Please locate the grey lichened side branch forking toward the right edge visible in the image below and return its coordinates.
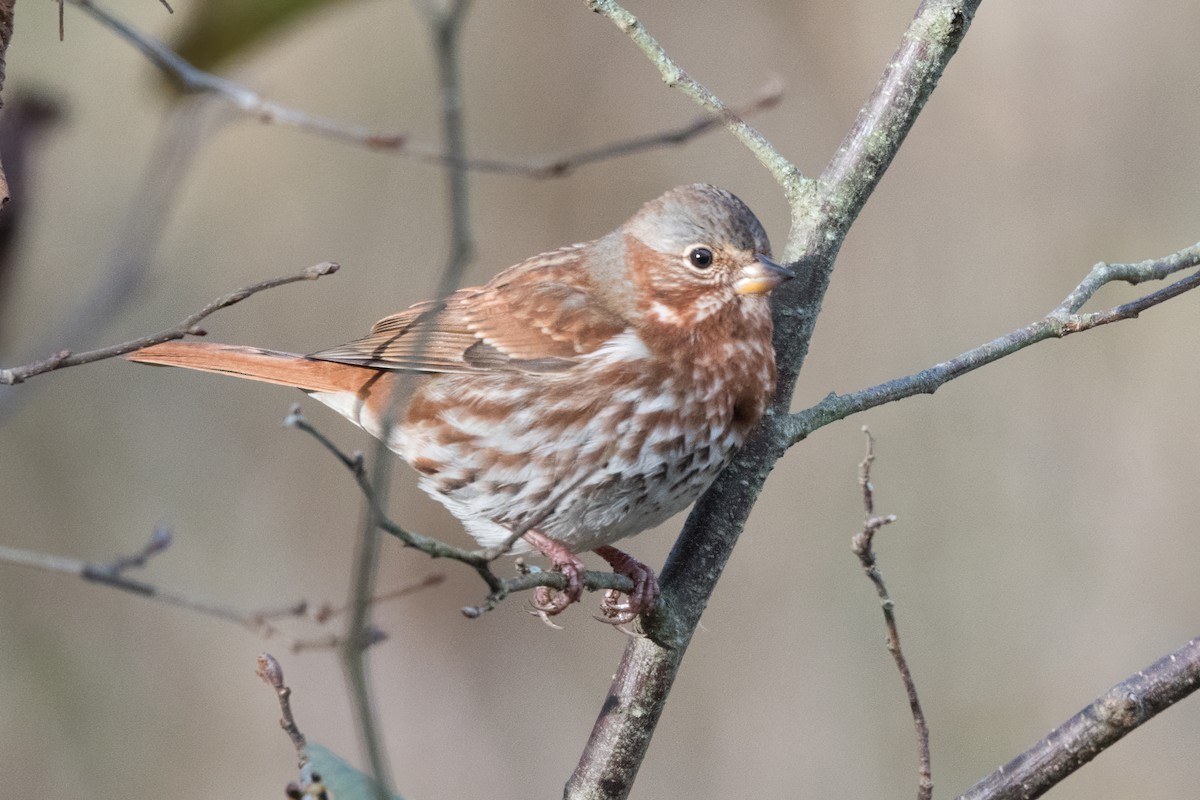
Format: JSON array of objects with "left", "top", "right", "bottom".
[{"left": 780, "top": 242, "right": 1200, "bottom": 444}]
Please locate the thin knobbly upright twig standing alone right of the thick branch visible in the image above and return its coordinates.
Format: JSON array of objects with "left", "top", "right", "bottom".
[{"left": 851, "top": 425, "right": 934, "bottom": 800}]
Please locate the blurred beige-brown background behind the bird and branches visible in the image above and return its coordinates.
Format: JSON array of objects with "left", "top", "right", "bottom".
[{"left": 0, "top": 0, "right": 1200, "bottom": 800}]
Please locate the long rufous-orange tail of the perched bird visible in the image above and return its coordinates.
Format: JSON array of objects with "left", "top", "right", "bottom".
[{"left": 125, "top": 342, "right": 380, "bottom": 393}]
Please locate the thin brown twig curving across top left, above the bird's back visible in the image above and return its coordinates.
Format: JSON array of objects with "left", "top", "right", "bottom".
[{"left": 59, "top": 0, "right": 782, "bottom": 179}]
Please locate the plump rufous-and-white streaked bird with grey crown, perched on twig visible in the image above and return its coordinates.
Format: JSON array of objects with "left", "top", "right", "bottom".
[{"left": 126, "top": 184, "right": 794, "bottom": 622}]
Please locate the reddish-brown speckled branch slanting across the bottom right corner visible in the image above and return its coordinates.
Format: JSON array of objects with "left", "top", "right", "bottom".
[{"left": 959, "top": 638, "right": 1200, "bottom": 800}]
